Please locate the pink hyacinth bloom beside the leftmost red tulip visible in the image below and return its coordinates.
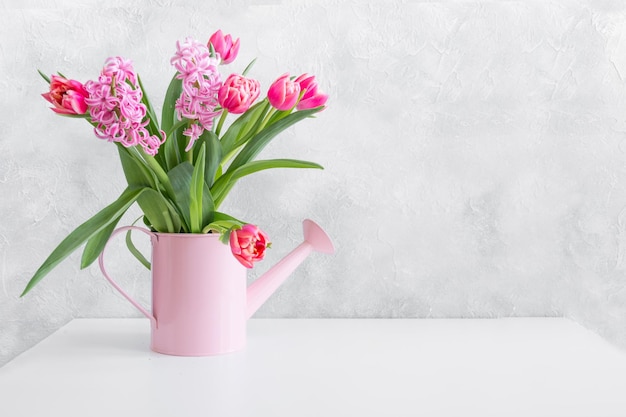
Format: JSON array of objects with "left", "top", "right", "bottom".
[{"left": 85, "top": 57, "right": 165, "bottom": 156}]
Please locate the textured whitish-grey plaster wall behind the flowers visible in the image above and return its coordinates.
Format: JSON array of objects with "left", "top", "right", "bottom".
[{"left": 0, "top": 0, "right": 626, "bottom": 364}]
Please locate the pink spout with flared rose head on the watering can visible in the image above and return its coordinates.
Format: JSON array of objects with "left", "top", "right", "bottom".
[{"left": 246, "top": 219, "right": 335, "bottom": 318}]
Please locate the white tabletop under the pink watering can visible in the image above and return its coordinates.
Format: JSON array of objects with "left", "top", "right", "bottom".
[{"left": 0, "top": 318, "right": 626, "bottom": 417}]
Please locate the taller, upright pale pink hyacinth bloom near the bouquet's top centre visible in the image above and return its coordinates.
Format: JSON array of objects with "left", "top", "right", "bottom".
[{"left": 170, "top": 38, "right": 222, "bottom": 150}]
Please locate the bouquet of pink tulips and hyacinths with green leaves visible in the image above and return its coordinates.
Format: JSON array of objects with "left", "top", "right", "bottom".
[{"left": 22, "top": 30, "right": 328, "bottom": 296}]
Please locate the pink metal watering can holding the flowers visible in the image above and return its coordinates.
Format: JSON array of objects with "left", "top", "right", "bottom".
[{"left": 98, "top": 219, "right": 334, "bottom": 356}]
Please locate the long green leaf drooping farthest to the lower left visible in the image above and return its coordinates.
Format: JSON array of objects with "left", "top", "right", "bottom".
[{"left": 21, "top": 187, "right": 148, "bottom": 297}]
